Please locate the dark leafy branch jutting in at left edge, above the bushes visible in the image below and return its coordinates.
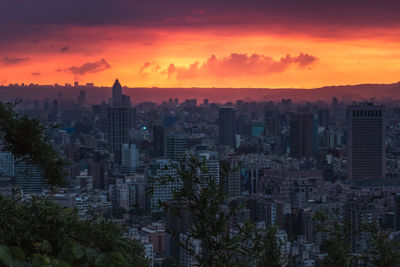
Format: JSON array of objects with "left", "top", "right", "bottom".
[{"left": 0, "top": 102, "right": 67, "bottom": 186}]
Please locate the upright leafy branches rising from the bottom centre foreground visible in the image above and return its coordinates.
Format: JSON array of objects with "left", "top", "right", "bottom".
[{"left": 153, "top": 156, "right": 283, "bottom": 266}]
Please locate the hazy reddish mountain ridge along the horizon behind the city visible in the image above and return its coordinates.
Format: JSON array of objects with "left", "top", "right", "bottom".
[{"left": 0, "top": 81, "right": 400, "bottom": 104}]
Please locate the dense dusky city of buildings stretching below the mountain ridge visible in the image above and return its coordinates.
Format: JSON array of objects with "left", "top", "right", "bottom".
[{"left": 0, "top": 80, "right": 400, "bottom": 267}]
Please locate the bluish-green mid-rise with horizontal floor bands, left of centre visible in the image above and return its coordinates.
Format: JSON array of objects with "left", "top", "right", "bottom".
[{"left": 165, "top": 133, "right": 188, "bottom": 160}]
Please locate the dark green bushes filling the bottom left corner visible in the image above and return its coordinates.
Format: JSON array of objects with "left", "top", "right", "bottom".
[{"left": 0, "top": 197, "right": 147, "bottom": 266}]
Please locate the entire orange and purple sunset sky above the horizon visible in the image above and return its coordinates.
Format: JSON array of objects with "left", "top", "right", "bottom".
[{"left": 0, "top": 0, "right": 400, "bottom": 88}]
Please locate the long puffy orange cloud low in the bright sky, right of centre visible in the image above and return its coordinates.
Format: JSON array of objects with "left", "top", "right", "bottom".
[{"left": 155, "top": 53, "right": 317, "bottom": 79}]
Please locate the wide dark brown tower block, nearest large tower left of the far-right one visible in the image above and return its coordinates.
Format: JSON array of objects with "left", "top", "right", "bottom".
[{"left": 289, "top": 113, "right": 318, "bottom": 158}]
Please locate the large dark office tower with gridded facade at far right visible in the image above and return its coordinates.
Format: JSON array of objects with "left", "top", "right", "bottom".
[{"left": 347, "top": 103, "right": 386, "bottom": 179}]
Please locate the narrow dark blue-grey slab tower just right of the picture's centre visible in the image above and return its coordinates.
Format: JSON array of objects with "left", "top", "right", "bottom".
[{"left": 219, "top": 107, "right": 236, "bottom": 148}]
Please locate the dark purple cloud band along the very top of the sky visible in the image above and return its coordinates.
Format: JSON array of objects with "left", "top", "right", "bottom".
[{"left": 0, "top": 0, "right": 400, "bottom": 29}]
